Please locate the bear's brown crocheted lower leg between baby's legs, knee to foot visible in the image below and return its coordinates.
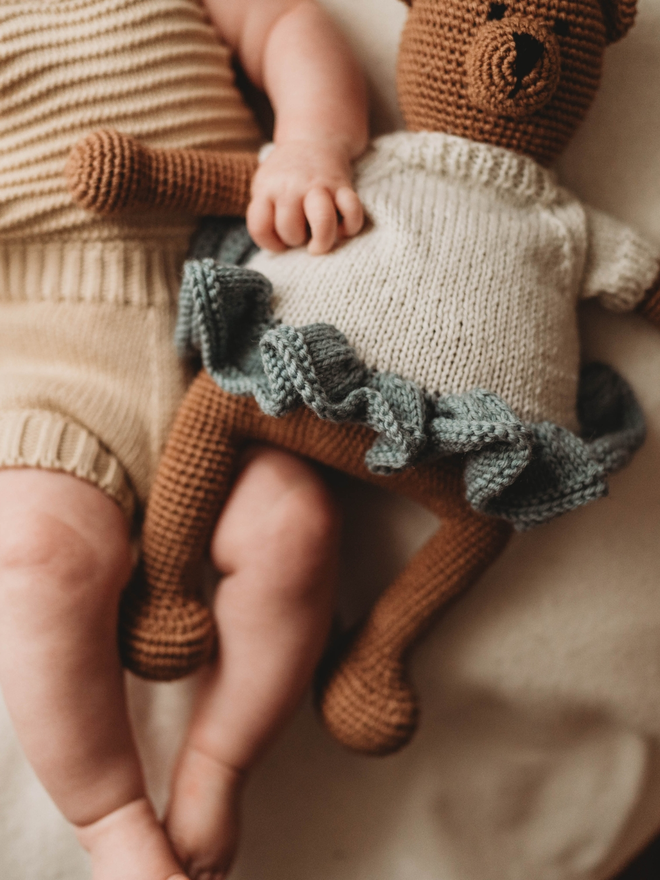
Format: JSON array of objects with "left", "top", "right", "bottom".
[{"left": 119, "top": 371, "right": 245, "bottom": 681}]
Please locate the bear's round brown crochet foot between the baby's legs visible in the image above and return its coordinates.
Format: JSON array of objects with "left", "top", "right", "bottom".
[{"left": 119, "top": 576, "right": 216, "bottom": 681}]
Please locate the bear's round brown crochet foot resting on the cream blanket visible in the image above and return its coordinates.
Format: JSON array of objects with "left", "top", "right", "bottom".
[{"left": 318, "top": 641, "right": 419, "bottom": 755}]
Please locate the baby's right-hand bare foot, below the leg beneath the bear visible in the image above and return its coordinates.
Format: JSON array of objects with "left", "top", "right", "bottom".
[{"left": 165, "top": 747, "right": 244, "bottom": 880}]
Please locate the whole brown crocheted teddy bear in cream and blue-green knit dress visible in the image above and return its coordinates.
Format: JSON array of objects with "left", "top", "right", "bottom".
[{"left": 68, "top": 0, "right": 660, "bottom": 754}]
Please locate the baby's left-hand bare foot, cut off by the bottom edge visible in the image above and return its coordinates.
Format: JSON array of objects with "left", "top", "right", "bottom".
[{"left": 75, "top": 798, "right": 187, "bottom": 880}]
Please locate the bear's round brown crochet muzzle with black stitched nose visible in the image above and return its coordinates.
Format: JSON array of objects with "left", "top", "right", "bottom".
[{"left": 466, "top": 16, "right": 561, "bottom": 116}]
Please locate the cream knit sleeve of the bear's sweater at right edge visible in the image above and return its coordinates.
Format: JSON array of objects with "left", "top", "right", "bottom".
[{"left": 580, "top": 207, "right": 660, "bottom": 312}]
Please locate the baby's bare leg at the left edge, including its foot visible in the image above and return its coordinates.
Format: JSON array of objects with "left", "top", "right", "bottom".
[{"left": 0, "top": 470, "right": 183, "bottom": 880}]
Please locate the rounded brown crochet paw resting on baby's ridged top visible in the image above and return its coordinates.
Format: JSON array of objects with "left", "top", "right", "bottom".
[{"left": 65, "top": 131, "right": 150, "bottom": 215}]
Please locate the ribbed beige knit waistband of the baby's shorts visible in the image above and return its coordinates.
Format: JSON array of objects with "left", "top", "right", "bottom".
[{"left": 0, "top": 240, "right": 187, "bottom": 307}]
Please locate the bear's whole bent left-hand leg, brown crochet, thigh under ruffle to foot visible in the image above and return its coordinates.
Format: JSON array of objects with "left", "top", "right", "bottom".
[{"left": 127, "top": 370, "right": 373, "bottom": 680}]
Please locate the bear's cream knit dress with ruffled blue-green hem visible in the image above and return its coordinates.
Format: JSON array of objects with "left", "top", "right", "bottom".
[{"left": 179, "top": 132, "right": 660, "bottom": 528}]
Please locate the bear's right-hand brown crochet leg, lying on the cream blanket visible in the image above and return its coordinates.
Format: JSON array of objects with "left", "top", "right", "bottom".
[{"left": 319, "top": 463, "right": 511, "bottom": 755}]
